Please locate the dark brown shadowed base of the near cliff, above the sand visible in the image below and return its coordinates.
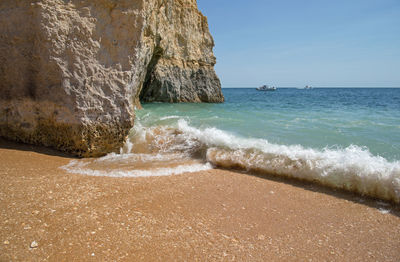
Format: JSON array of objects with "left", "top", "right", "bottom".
[{"left": 0, "top": 109, "right": 132, "bottom": 157}]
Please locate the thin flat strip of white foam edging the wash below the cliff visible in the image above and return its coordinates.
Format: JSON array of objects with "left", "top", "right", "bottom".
[{"left": 61, "top": 160, "right": 212, "bottom": 177}]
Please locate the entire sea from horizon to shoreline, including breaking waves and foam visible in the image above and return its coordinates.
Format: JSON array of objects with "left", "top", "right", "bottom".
[{"left": 63, "top": 88, "right": 400, "bottom": 203}]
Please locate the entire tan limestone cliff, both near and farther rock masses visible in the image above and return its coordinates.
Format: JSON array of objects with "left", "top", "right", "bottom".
[{"left": 0, "top": 0, "right": 224, "bottom": 156}]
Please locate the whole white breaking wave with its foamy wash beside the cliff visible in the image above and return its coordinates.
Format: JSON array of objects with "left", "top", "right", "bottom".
[{"left": 64, "top": 114, "right": 400, "bottom": 203}]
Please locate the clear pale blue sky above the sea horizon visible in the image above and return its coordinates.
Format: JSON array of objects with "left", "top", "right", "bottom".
[{"left": 197, "top": 0, "right": 400, "bottom": 87}]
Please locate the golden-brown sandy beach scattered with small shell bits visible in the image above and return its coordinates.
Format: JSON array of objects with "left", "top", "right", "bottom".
[{"left": 0, "top": 140, "right": 400, "bottom": 261}]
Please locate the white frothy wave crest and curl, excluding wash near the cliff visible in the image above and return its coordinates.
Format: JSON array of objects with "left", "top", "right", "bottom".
[{"left": 141, "top": 119, "right": 400, "bottom": 202}]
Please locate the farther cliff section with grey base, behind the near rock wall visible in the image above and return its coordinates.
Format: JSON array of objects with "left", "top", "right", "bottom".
[{"left": 140, "top": 0, "right": 224, "bottom": 102}]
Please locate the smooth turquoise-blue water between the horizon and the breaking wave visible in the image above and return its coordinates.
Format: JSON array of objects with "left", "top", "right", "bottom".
[{"left": 137, "top": 88, "right": 400, "bottom": 161}]
